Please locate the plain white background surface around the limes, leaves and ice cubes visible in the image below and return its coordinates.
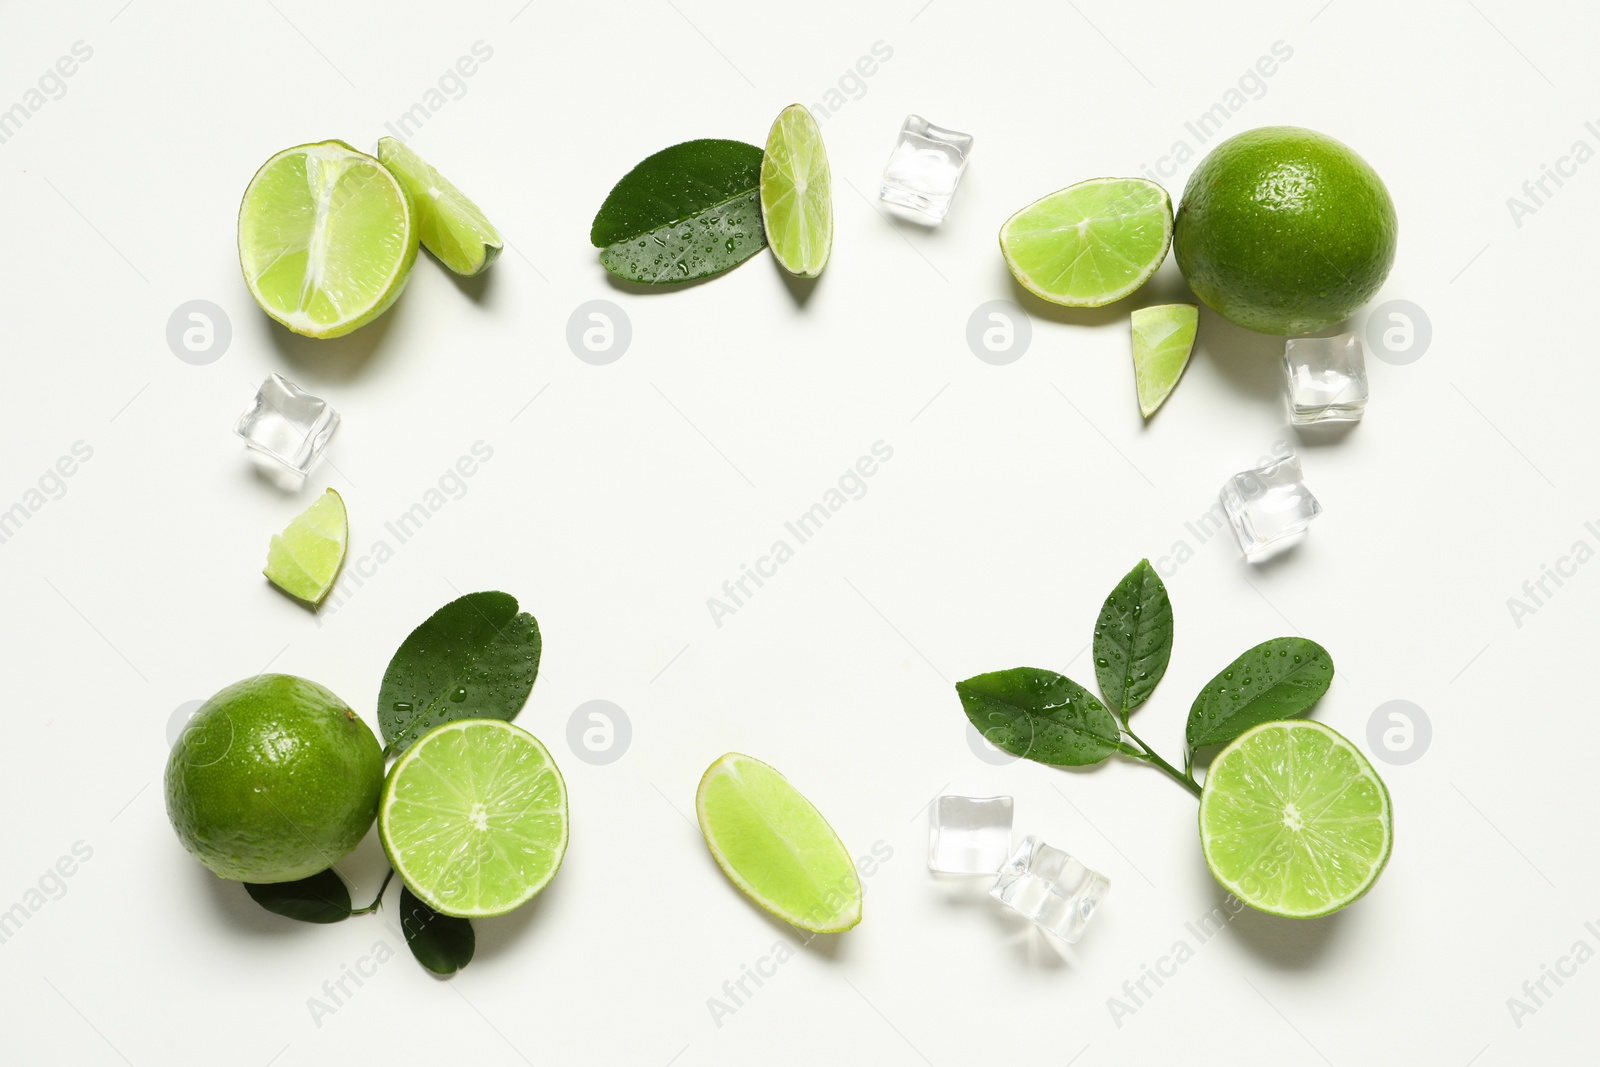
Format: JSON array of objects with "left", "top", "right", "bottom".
[{"left": 0, "top": 0, "right": 1600, "bottom": 1067}]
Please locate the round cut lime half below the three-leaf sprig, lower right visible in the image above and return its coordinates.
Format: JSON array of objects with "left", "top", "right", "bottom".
[{"left": 1200, "top": 720, "right": 1394, "bottom": 918}]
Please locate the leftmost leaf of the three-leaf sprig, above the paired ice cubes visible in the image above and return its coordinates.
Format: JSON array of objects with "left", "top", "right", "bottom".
[{"left": 955, "top": 667, "right": 1122, "bottom": 766}]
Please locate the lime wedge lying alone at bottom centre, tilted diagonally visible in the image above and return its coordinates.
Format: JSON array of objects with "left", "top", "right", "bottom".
[{"left": 694, "top": 752, "right": 861, "bottom": 934}]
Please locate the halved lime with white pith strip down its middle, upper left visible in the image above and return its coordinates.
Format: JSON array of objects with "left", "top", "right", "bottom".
[{"left": 238, "top": 141, "right": 418, "bottom": 338}]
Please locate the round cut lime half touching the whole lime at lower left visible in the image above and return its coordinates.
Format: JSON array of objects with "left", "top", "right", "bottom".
[{"left": 378, "top": 718, "right": 566, "bottom": 918}]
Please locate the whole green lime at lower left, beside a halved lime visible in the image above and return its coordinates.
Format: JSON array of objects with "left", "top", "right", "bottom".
[{"left": 166, "top": 675, "right": 384, "bottom": 881}]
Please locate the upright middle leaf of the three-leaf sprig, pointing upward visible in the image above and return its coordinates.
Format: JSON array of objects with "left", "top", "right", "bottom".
[{"left": 1094, "top": 560, "right": 1173, "bottom": 715}]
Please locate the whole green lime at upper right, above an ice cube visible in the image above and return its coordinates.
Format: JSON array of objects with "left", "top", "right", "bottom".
[{"left": 1173, "top": 126, "right": 1397, "bottom": 334}]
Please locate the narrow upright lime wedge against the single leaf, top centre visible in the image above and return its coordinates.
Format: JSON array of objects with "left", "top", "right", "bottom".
[{"left": 762, "top": 104, "right": 834, "bottom": 278}]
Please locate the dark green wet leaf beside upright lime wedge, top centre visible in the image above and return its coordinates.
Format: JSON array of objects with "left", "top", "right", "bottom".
[{"left": 589, "top": 139, "right": 766, "bottom": 285}]
